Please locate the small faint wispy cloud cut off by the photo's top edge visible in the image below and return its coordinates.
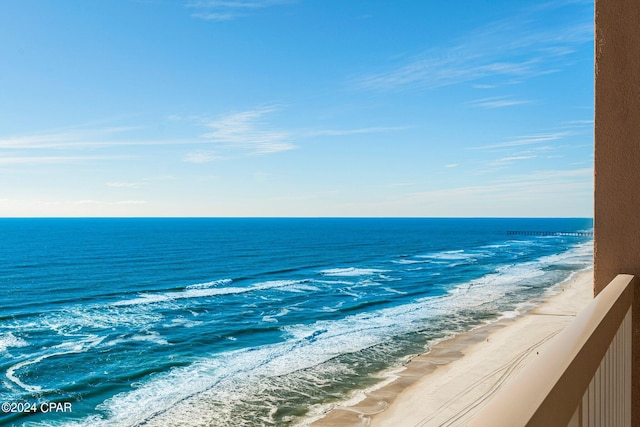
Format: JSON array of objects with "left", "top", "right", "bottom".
[{"left": 186, "top": 0, "right": 294, "bottom": 21}]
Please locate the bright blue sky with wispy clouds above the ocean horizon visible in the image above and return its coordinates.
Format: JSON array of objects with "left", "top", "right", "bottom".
[{"left": 0, "top": 0, "right": 593, "bottom": 217}]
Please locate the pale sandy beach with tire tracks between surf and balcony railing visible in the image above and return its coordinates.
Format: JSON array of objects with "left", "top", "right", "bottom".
[{"left": 311, "top": 270, "right": 593, "bottom": 427}]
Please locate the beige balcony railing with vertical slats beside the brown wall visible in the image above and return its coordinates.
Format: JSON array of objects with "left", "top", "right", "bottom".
[{"left": 467, "top": 274, "right": 637, "bottom": 427}]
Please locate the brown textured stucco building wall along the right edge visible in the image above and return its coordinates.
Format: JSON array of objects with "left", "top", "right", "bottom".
[{"left": 594, "top": 0, "right": 640, "bottom": 425}]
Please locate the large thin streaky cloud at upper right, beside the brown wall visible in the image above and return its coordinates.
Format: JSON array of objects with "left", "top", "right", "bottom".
[{"left": 354, "top": 4, "right": 593, "bottom": 90}]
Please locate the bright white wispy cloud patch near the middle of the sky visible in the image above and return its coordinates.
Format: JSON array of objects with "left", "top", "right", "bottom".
[{"left": 201, "top": 107, "right": 297, "bottom": 154}]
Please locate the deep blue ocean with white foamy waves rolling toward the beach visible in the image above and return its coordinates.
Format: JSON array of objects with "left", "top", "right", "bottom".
[{"left": 0, "top": 218, "right": 593, "bottom": 427}]
